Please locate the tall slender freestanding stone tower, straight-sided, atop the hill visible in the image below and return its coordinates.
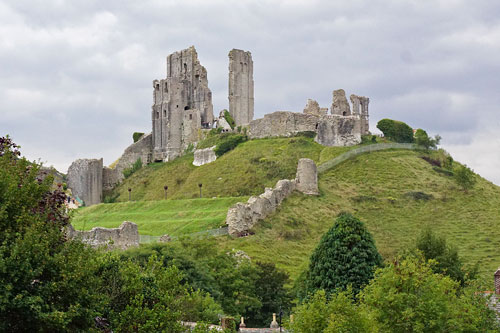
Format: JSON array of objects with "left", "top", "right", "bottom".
[{"left": 229, "top": 49, "right": 254, "bottom": 126}]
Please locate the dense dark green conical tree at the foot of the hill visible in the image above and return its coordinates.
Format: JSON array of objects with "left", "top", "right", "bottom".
[{"left": 307, "top": 213, "right": 382, "bottom": 294}]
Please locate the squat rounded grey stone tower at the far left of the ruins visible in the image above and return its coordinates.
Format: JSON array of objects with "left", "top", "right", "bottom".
[{"left": 68, "top": 158, "right": 103, "bottom": 206}]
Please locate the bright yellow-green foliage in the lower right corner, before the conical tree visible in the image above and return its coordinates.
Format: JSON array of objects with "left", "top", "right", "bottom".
[{"left": 290, "top": 257, "right": 499, "bottom": 333}]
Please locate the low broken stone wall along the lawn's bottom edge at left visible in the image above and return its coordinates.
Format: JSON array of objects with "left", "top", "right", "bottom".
[{"left": 66, "top": 221, "right": 139, "bottom": 250}]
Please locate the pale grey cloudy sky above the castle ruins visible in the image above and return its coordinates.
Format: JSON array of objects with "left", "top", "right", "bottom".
[{"left": 0, "top": 0, "right": 500, "bottom": 185}]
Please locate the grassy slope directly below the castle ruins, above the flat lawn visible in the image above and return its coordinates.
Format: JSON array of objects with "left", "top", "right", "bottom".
[{"left": 112, "top": 137, "right": 351, "bottom": 201}]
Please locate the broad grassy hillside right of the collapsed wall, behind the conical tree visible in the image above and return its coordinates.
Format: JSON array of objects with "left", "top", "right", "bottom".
[{"left": 221, "top": 150, "right": 500, "bottom": 285}]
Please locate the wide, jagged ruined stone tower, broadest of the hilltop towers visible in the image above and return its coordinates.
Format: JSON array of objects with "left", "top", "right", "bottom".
[{"left": 151, "top": 46, "right": 214, "bottom": 161}]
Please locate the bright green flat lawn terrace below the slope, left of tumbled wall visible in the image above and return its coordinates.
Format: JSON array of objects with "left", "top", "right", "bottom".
[{"left": 71, "top": 197, "right": 248, "bottom": 236}]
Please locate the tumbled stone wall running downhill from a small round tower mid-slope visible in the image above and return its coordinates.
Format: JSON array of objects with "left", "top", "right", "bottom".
[{"left": 226, "top": 158, "right": 319, "bottom": 236}]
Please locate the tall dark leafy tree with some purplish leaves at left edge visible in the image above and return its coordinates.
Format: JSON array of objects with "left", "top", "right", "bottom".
[{"left": 0, "top": 137, "right": 100, "bottom": 332}]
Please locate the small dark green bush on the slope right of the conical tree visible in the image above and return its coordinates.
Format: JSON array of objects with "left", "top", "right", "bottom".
[{"left": 416, "top": 228, "right": 477, "bottom": 286}]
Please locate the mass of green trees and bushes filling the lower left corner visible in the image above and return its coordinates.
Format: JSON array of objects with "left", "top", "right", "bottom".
[{"left": 0, "top": 138, "right": 222, "bottom": 332}]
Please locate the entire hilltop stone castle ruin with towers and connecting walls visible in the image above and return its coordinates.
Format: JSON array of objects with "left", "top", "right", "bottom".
[{"left": 68, "top": 46, "right": 370, "bottom": 206}]
